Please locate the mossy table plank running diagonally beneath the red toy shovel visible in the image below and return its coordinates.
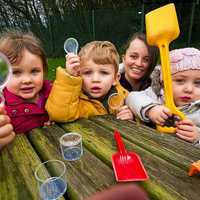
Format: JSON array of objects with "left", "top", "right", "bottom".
[{"left": 63, "top": 119, "right": 200, "bottom": 199}]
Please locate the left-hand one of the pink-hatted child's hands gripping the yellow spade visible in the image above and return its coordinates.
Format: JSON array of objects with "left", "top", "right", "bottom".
[{"left": 146, "top": 105, "right": 172, "bottom": 126}]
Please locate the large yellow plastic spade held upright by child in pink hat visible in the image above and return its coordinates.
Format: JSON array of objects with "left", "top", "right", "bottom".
[{"left": 145, "top": 3, "right": 185, "bottom": 133}]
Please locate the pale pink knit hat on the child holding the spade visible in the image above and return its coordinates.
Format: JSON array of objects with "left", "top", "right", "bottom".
[{"left": 169, "top": 48, "right": 200, "bottom": 74}]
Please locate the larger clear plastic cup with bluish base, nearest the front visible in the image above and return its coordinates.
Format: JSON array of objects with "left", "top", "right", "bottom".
[{"left": 35, "top": 160, "right": 67, "bottom": 200}]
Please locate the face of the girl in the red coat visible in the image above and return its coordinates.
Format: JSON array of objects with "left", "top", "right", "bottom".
[{"left": 7, "top": 49, "right": 44, "bottom": 102}]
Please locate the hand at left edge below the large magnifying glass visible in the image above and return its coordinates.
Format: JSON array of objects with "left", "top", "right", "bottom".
[{"left": 0, "top": 107, "right": 15, "bottom": 149}]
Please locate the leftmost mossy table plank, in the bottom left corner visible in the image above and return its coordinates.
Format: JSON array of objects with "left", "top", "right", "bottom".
[{"left": 0, "top": 135, "right": 43, "bottom": 200}]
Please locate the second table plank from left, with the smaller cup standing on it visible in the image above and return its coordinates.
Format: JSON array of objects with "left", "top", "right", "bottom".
[{"left": 29, "top": 125, "right": 115, "bottom": 200}]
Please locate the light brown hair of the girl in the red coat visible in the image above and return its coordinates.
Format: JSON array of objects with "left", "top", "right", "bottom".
[{"left": 0, "top": 30, "right": 48, "bottom": 72}]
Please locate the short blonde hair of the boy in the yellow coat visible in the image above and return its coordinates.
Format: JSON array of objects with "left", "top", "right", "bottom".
[{"left": 79, "top": 41, "right": 119, "bottom": 74}]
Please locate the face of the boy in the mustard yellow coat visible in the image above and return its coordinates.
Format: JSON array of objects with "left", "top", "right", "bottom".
[{"left": 80, "top": 60, "right": 117, "bottom": 99}]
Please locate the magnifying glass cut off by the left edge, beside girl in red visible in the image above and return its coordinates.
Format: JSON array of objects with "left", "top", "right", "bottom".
[{"left": 0, "top": 52, "right": 12, "bottom": 106}]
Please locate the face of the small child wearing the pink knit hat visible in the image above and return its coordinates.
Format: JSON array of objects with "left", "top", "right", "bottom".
[{"left": 172, "top": 70, "right": 200, "bottom": 106}]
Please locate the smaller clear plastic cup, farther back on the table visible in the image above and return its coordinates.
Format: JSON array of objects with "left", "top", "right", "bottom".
[{"left": 60, "top": 132, "right": 83, "bottom": 161}]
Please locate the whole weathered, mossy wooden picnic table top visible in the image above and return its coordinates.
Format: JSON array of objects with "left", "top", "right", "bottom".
[{"left": 0, "top": 115, "right": 200, "bottom": 200}]
